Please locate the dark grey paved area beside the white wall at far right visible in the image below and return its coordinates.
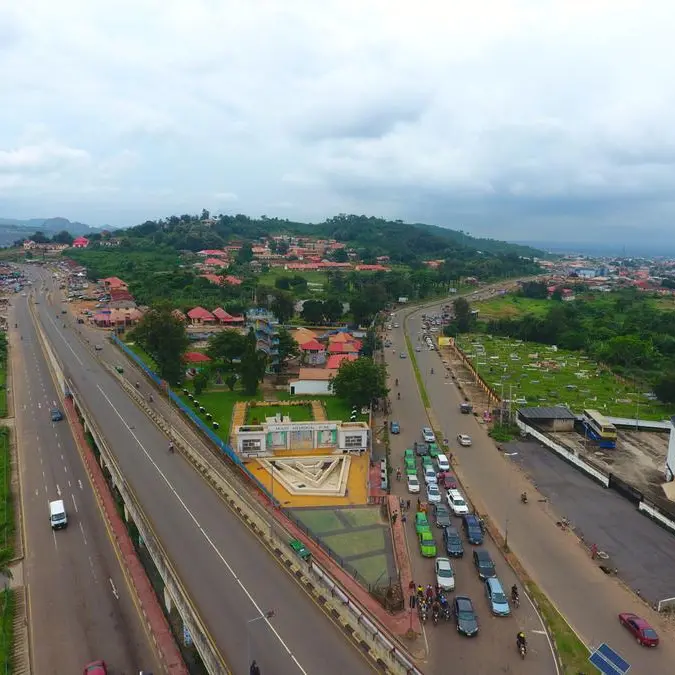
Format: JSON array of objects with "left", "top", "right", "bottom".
[{"left": 504, "top": 441, "right": 675, "bottom": 604}]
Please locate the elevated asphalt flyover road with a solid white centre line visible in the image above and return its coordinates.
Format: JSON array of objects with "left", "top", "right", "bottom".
[{"left": 26, "top": 270, "right": 371, "bottom": 675}]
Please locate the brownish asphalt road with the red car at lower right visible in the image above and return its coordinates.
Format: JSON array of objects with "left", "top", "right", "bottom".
[{"left": 390, "top": 306, "right": 675, "bottom": 673}]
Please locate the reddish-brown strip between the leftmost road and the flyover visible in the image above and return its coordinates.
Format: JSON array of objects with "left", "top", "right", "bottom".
[{"left": 31, "top": 310, "right": 191, "bottom": 675}]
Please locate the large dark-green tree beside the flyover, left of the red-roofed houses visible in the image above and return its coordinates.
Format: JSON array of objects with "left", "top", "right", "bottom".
[{"left": 131, "top": 305, "right": 190, "bottom": 384}]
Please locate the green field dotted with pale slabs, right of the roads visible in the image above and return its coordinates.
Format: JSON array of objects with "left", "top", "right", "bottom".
[{"left": 457, "top": 334, "right": 673, "bottom": 420}]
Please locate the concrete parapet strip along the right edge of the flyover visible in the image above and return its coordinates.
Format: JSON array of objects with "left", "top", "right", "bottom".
[{"left": 106, "top": 366, "right": 428, "bottom": 675}]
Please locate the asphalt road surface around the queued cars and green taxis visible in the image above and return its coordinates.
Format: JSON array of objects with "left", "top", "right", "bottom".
[{"left": 386, "top": 327, "right": 556, "bottom": 675}]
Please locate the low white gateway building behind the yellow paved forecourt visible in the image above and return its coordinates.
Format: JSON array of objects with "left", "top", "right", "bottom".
[{"left": 234, "top": 417, "right": 369, "bottom": 459}]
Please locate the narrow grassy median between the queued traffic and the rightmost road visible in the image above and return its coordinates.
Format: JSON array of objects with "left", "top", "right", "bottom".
[{"left": 402, "top": 312, "right": 568, "bottom": 672}]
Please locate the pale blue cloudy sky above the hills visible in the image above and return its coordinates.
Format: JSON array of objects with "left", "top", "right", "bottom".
[{"left": 0, "top": 0, "right": 675, "bottom": 248}]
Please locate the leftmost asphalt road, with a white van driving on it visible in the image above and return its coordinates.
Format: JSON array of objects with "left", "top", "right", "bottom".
[{"left": 9, "top": 296, "right": 159, "bottom": 675}]
